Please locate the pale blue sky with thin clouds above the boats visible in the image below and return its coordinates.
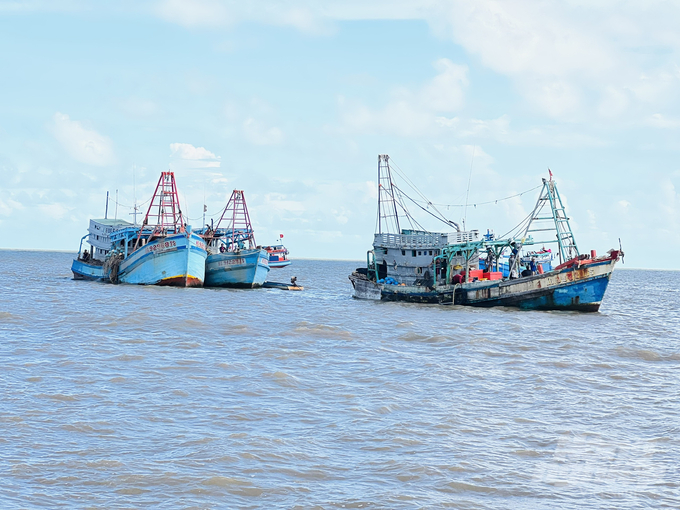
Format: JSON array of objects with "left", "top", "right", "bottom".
[{"left": 0, "top": 0, "right": 680, "bottom": 269}]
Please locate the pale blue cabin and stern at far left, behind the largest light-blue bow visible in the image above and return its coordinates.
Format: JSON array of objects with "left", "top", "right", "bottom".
[{"left": 71, "top": 217, "right": 132, "bottom": 280}]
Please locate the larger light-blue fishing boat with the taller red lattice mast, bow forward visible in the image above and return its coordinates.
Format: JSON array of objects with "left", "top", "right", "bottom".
[{"left": 103, "top": 172, "right": 207, "bottom": 287}]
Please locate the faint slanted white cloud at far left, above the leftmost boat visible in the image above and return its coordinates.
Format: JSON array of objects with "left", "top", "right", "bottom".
[{"left": 49, "top": 112, "right": 116, "bottom": 166}]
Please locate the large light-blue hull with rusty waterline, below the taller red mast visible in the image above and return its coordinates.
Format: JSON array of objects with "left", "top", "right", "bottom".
[{"left": 117, "top": 233, "right": 207, "bottom": 287}]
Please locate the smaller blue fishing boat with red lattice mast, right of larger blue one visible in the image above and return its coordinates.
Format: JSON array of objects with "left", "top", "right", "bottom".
[{"left": 201, "top": 190, "right": 269, "bottom": 288}]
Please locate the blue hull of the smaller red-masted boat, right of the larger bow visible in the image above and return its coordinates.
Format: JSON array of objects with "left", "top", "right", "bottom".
[{"left": 204, "top": 249, "right": 269, "bottom": 288}]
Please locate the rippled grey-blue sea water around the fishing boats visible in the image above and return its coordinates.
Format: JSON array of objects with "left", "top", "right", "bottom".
[{"left": 0, "top": 251, "right": 680, "bottom": 509}]
